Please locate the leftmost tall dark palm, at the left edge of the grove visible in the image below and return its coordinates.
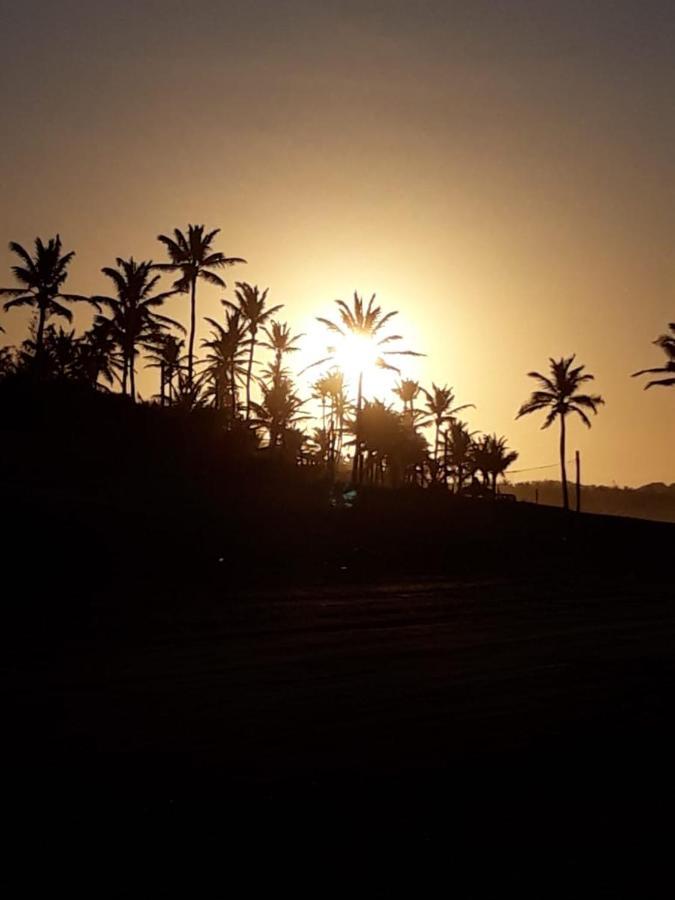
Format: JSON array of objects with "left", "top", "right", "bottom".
[{"left": 0, "top": 234, "right": 96, "bottom": 366}]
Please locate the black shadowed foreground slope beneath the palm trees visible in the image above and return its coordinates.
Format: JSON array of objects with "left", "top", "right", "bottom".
[{"left": 0, "top": 383, "right": 675, "bottom": 898}]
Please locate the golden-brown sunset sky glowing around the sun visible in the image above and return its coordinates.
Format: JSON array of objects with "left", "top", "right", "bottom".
[{"left": 0, "top": 0, "right": 675, "bottom": 485}]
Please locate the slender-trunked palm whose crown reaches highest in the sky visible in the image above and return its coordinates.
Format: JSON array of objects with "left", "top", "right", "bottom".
[{"left": 155, "top": 225, "right": 246, "bottom": 383}]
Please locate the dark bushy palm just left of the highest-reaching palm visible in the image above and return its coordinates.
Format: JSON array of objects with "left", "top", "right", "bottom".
[{"left": 93, "top": 257, "right": 185, "bottom": 402}]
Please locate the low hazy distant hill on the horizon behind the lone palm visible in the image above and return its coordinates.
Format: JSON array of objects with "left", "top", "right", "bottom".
[{"left": 503, "top": 481, "right": 675, "bottom": 522}]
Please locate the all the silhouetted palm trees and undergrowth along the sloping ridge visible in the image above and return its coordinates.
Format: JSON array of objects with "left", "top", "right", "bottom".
[{"left": 0, "top": 225, "right": 675, "bottom": 507}]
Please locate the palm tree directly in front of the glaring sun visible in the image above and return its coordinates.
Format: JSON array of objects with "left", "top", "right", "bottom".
[{"left": 313, "top": 292, "right": 423, "bottom": 483}]
